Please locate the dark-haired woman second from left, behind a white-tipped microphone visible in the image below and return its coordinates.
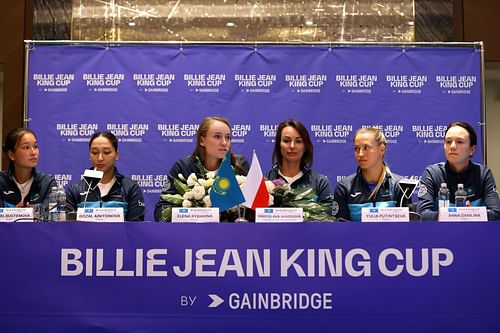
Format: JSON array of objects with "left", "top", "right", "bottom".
[{"left": 66, "top": 132, "right": 145, "bottom": 221}]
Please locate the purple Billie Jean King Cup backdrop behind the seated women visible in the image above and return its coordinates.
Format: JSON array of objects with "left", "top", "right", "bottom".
[{"left": 28, "top": 44, "right": 482, "bottom": 220}]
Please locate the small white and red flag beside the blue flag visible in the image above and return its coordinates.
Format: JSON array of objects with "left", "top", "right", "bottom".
[{"left": 241, "top": 151, "right": 269, "bottom": 209}]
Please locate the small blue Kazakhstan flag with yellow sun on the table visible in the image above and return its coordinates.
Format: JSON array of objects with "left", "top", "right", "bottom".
[{"left": 210, "top": 151, "right": 245, "bottom": 212}]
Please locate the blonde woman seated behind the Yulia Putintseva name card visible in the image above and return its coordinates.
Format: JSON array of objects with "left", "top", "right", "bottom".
[{"left": 332, "top": 127, "right": 403, "bottom": 221}]
